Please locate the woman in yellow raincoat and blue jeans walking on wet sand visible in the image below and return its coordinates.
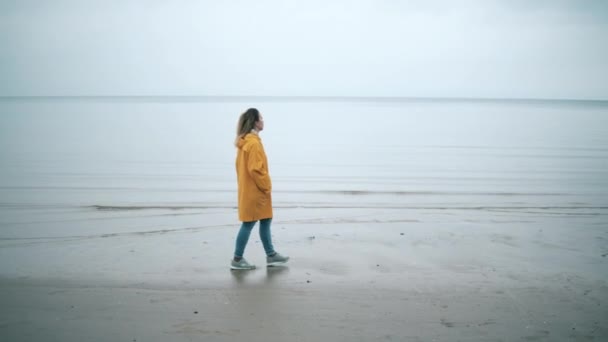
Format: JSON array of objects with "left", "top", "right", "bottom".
[{"left": 230, "top": 108, "right": 289, "bottom": 270}]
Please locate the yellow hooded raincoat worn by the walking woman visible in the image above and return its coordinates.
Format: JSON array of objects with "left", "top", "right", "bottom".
[{"left": 236, "top": 133, "right": 272, "bottom": 222}]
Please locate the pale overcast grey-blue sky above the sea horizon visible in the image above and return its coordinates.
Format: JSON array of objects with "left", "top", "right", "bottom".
[{"left": 0, "top": 0, "right": 608, "bottom": 99}]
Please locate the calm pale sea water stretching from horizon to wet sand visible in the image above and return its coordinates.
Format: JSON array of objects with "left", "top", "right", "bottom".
[{"left": 0, "top": 98, "right": 608, "bottom": 241}]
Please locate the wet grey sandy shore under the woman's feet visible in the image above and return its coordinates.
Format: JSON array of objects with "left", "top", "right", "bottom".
[{"left": 0, "top": 204, "right": 608, "bottom": 342}]
